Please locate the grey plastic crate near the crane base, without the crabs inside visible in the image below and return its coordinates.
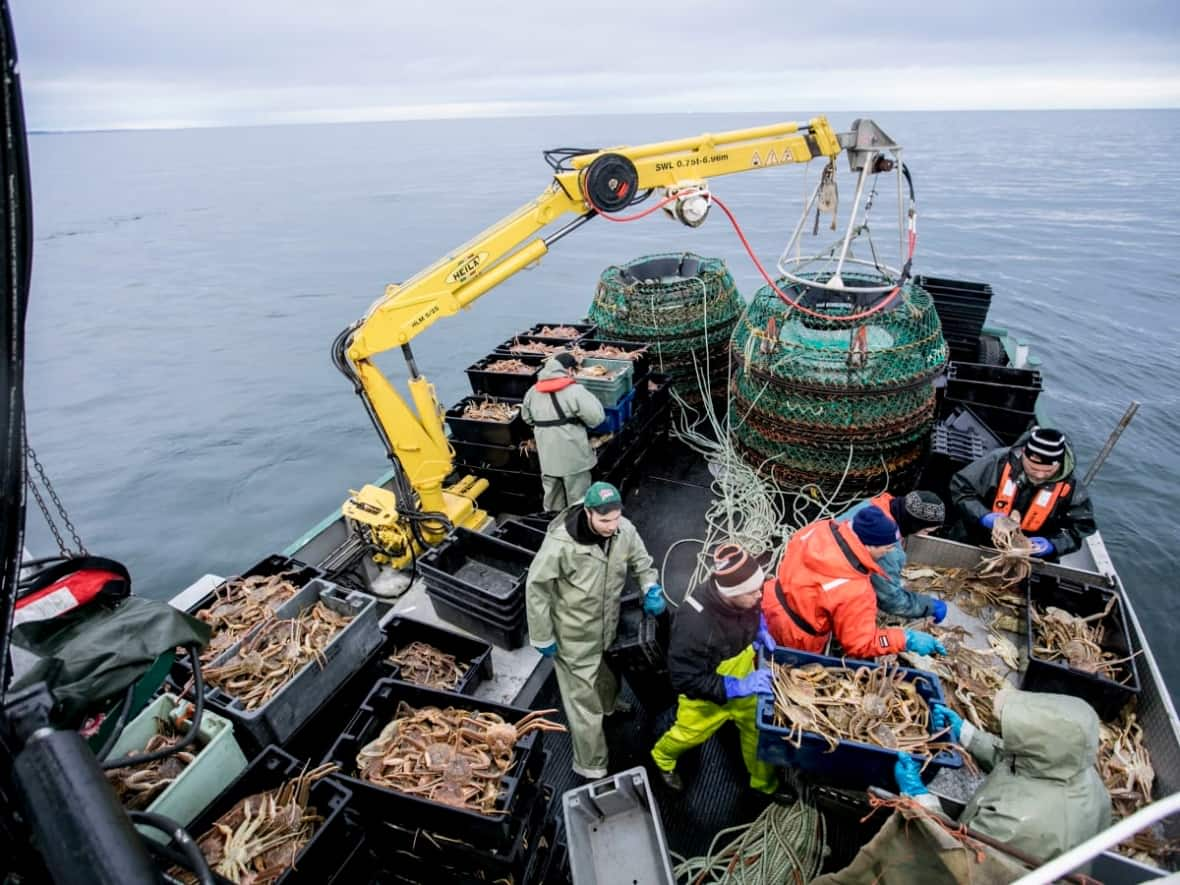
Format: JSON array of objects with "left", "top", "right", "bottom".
[{"left": 199, "top": 578, "right": 384, "bottom": 749}]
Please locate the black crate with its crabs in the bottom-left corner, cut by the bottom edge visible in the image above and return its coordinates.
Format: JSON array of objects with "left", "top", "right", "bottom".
[{"left": 162, "top": 747, "right": 354, "bottom": 885}]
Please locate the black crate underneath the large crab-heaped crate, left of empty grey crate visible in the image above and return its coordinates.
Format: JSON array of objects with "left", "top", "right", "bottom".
[{"left": 359, "top": 784, "right": 553, "bottom": 885}]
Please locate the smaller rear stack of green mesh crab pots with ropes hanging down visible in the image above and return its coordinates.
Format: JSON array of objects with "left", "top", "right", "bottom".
[{"left": 589, "top": 253, "right": 745, "bottom": 404}]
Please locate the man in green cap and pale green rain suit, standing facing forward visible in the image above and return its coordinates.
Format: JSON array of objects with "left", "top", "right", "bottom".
[{"left": 525, "top": 483, "right": 664, "bottom": 779}]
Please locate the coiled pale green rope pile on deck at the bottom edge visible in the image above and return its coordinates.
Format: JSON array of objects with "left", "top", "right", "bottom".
[{"left": 673, "top": 802, "right": 825, "bottom": 885}]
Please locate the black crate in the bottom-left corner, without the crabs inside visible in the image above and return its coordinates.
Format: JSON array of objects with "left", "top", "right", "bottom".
[{"left": 161, "top": 747, "right": 353, "bottom": 885}]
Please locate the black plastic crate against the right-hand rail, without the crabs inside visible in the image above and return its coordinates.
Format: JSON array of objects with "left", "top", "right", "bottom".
[{"left": 1021, "top": 572, "right": 1139, "bottom": 720}]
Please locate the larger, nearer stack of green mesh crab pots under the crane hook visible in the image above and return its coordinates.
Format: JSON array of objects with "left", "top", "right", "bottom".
[{"left": 729, "top": 274, "right": 946, "bottom": 497}]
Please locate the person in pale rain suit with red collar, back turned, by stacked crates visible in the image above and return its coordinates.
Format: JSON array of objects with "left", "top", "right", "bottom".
[{"left": 520, "top": 353, "right": 607, "bottom": 512}]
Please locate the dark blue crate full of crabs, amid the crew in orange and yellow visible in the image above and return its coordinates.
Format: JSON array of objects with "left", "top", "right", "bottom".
[{"left": 758, "top": 648, "right": 963, "bottom": 789}]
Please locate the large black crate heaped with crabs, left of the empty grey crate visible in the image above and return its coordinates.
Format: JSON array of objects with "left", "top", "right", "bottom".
[{"left": 325, "top": 680, "right": 565, "bottom": 847}]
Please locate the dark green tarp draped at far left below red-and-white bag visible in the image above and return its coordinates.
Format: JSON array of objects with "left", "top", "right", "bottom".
[{"left": 12, "top": 596, "right": 209, "bottom": 727}]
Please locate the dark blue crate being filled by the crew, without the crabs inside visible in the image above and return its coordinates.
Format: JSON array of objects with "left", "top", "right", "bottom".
[{"left": 758, "top": 648, "right": 963, "bottom": 789}]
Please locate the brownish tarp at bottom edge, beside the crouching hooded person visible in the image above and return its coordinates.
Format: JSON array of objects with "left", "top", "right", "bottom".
[{"left": 812, "top": 808, "right": 1028, "bottom": 885}]
